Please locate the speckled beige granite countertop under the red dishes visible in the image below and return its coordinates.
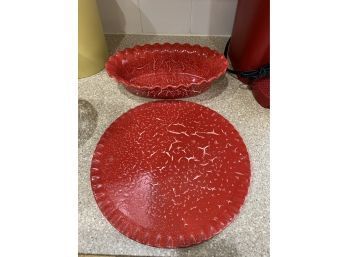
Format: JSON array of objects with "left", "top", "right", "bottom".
[{"left": 78, "top": 35, "right": 270, "bottom": 257}]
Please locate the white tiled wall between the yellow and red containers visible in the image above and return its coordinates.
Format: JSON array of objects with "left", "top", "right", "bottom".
[{"left": 97, "top": 0, "right": 237, "bottom": 36}]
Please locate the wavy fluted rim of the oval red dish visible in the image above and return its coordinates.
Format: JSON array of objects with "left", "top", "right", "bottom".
[{"left": 105, "top": 42, "right": 228, "bottom": 90}]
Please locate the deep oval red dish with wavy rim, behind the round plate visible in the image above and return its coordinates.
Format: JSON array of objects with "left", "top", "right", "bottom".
[{"left": 105, "top": 43, "right": 227, "bottom": 98}]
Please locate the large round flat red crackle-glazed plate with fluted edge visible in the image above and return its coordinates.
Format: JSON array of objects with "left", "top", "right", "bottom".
[{"left": 91, "top": 101, "right": 250, "bottom": 248}]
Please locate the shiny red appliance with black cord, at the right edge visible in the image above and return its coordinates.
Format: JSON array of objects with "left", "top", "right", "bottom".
[{"left": 225, "top": 0, "right": 270, "bottom": 108}]
